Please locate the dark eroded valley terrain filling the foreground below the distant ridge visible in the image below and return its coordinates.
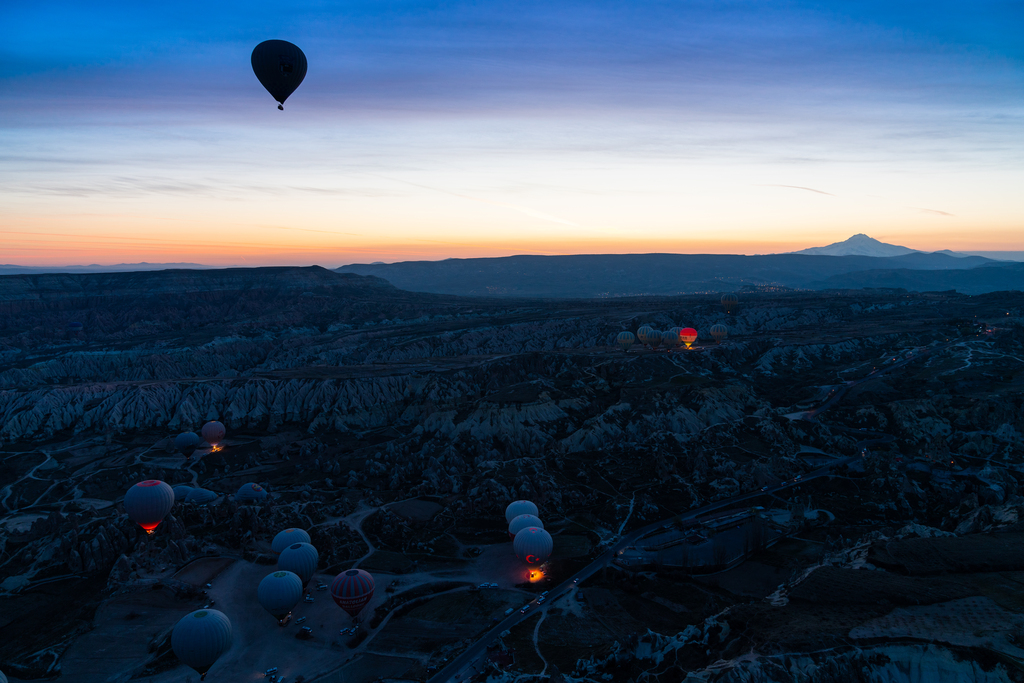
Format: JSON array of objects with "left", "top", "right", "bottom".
[{"left": 0, "top": 266, "right": 1024, "bottom": 683}]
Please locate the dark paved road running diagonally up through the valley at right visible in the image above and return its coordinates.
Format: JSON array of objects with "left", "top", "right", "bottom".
[{"left": 428, "top": 340, "right": 963, "bottom": 683}]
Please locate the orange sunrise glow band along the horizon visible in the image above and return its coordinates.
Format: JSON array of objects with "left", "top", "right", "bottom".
[{"left": 8, "top": 219, "right": 1024, "bottom": 267}]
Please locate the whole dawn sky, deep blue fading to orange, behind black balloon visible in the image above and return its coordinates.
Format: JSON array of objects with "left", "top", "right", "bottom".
[{"left": 0, "top": 0, "right": 1024, "bottom": 265}]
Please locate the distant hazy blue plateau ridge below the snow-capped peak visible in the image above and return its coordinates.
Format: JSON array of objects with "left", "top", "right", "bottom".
[{"left": 338, "top": 252, "right": 1024, "bottom": 298}]
